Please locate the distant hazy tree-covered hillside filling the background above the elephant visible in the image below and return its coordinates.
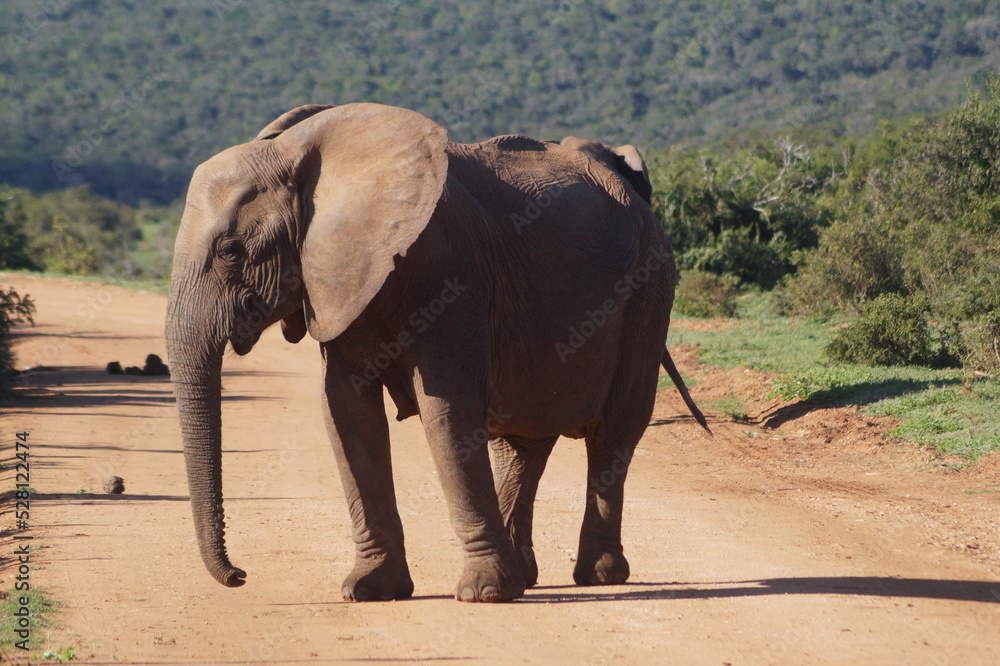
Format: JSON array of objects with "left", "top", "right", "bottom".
[{"left": 0, "top": 0, "right": 1000, "bottom": 204}]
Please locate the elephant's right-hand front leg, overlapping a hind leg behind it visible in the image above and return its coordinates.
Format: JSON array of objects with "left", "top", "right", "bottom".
[{"left": 420, "top": 396, "right": 525, "bottom": 602}]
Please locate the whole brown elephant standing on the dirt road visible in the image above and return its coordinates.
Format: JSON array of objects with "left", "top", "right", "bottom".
[{"left": 165, "top": 103, "right": 708, "bottom": 602}]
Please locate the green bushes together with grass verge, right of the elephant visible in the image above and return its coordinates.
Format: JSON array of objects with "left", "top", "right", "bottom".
[{"left": 655, "top": 79, "right": 1000, "bottom": 460}]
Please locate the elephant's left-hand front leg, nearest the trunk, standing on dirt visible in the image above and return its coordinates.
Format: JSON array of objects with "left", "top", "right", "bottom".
[{"left": 323, "top": 345, "right": 413, "bottom": 601}]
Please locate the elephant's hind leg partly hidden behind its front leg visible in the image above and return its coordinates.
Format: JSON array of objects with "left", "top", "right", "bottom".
[{"left": 490, "top": 436, "right": 558, "bottom": 587}]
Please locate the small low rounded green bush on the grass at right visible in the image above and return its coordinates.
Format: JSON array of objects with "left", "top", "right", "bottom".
[{"left": 826, "top": 294, "right": 956, "bottom": 367}]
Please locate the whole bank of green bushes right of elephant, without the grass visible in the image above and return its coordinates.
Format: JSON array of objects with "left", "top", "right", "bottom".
[{"left": 653, "top": 79, "right": 1000, "bottom": 375}]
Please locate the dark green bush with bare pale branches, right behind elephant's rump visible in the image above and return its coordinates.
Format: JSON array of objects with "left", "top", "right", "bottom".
[{"left": 650, "top": 138, "right": 842, "bottom": 289}]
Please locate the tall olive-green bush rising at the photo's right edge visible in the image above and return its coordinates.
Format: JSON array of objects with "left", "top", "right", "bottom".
[{"left": 787, "top": 79, "right": 1000, "bottom": 374}]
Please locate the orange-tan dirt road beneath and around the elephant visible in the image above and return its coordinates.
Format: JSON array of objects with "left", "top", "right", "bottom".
[{"left": 0, "top": 275, "right": 1000, "bottom": 664}]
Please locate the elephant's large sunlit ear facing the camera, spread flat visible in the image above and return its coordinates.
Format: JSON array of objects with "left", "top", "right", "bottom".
[{"left": 274, "top": 104, "right": 448, "bottom": 342}]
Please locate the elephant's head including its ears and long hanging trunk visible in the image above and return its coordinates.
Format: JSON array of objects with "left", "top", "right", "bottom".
[{"left": 166, "top": 104, "right": 448, "bottom": 586}]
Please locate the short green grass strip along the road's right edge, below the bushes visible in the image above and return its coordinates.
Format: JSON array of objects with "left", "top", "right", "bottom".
[{"left": 670, "top": 310, "right": 1000, "bottom": 462}]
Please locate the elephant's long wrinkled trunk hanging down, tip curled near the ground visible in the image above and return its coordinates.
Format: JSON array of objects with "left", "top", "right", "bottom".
[{"left": 166, "top": 281, "right": 246, "bottom": 587}]
